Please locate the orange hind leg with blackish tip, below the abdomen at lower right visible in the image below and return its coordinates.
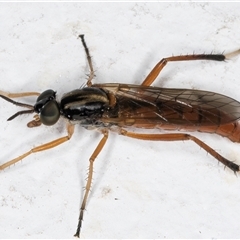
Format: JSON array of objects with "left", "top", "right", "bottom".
[{"left": 119, "top": 129, "right": 240, "bottom": 173}]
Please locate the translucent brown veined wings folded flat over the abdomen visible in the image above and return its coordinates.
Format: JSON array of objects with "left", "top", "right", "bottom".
[{"left": 93, "top": 84, "right": 240, "bottom": 126}]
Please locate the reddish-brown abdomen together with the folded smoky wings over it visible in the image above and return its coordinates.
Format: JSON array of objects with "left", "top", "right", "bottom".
[{"left": 92, "top": 83, "right": 240, "bottom": 142}]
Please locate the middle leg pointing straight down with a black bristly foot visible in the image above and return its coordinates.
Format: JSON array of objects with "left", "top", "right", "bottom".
[{"left": 74, "top": 130, "right": 108, "bottom": 237}]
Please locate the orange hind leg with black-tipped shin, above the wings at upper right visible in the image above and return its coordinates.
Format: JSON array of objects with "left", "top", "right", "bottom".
[{"left": 142, "top": 54, "right": 226, "bottom": 86}]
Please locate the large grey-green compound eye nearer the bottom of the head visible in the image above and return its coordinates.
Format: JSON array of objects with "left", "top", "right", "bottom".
[{"left": 40, "top": 101, "right": 60, "bottom": 126}]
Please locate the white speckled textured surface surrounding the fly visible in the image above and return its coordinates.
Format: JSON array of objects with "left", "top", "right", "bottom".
[{"left": 0, "top": 3, "right": 240, "bottom": 238}]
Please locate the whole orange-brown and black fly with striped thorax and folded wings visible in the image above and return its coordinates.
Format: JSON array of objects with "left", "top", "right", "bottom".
[{"left": 0, "top": 35, "right": 240, "bottom": 237}]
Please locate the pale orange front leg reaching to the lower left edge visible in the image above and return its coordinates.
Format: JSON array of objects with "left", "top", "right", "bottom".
[{"left": 0, "top": 124, "right": 74, "bottom": 171}]
